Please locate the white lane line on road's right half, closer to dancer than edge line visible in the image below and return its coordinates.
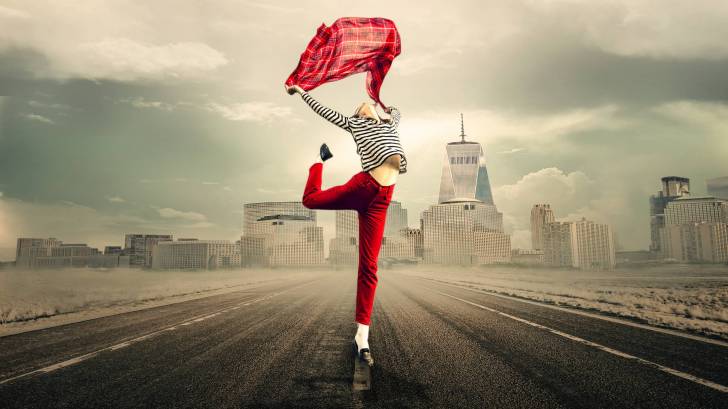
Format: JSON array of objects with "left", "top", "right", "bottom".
[{"left": 435, "top": 290, "right": 728, "bottom": 393}]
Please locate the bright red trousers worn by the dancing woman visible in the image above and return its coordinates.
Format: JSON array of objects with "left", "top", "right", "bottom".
[{"left": 303, "top": 162, "right": 394, "bottom": 325}]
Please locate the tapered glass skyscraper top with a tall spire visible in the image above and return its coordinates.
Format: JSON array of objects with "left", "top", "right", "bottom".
[{"left": 438, "top": 114, "right": 494, "bottom": 205}]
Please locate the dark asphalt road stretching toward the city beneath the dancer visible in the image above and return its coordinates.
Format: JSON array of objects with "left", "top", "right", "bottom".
[{"left": 0, "top": 270, "right": 728, "bottom": 408}]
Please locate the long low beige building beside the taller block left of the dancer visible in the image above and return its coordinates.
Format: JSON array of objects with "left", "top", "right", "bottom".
[{"left": 152, "top": 239, "right": 241, "bottom": 270}]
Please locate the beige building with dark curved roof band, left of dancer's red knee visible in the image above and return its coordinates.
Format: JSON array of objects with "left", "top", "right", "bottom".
[{"left": 240, "top": 201, "right": 324, "bottom": 267}]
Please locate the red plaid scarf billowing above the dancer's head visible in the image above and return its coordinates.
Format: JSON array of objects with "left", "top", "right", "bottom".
[{"left": 286, "top": 17, "right": 402, "bottom": 108}]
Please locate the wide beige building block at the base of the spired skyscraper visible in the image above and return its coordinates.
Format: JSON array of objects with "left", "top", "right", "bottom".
[{"left": 421, "top": 198, "right": 511, "bottom": 265}]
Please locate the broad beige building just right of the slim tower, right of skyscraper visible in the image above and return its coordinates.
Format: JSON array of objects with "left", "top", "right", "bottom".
[{"left": 544, "top": 219, "right": 616, "bottom": 270}]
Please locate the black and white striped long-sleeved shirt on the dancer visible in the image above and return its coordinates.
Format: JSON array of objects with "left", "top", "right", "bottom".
[{"left": 301, "top": 91, "right": 407, "bottom": 173}]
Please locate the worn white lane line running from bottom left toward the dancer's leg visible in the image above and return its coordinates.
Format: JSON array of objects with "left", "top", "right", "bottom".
[{"left": 0, "top": 281, "right": 314, "bottom": 385}]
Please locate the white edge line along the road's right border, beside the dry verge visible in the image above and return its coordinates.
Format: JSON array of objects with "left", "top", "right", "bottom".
[{"left": 418, "top": 277, "right": 728, "bottom": 347}]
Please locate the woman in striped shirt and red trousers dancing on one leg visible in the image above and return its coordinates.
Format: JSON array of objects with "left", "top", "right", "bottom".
[{"left": 285, "top": 85, "right": 407, "bottom": 366}]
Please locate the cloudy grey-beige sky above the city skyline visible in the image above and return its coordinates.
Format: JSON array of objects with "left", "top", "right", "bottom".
[{"left": 0, "top": 0, "right": 728, "bottom": 258}]
